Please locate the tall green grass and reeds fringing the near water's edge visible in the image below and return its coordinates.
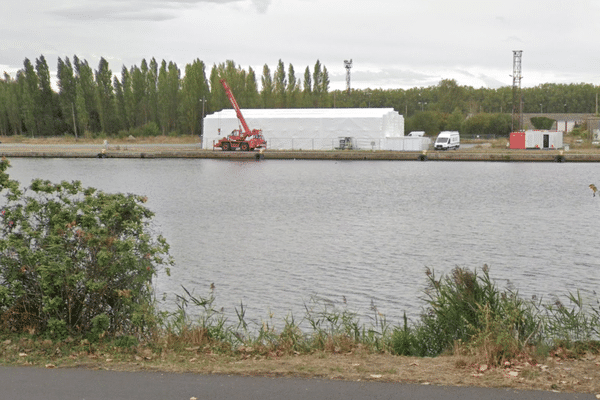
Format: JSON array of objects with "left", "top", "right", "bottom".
[{"left": 0, "top": 266, "right": 600, "bottom": 365}]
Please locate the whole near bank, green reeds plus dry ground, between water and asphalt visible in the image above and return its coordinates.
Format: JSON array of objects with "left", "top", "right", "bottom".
[{"left": 0, "top": 268, "right": 600, "bottom": 393}]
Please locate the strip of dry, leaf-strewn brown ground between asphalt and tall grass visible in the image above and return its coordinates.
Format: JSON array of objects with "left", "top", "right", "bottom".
[{"left": 0, "top": 340, "right": 600, "bottom": 398}]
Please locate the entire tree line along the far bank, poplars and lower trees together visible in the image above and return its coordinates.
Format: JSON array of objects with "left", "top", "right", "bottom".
[{"left": 0, "top": 55, "right": 599, "bottom": 137}]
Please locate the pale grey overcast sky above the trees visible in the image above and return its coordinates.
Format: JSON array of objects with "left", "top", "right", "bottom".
[{"left": 0, "top": 0, "right": 600, "bottom": 90}]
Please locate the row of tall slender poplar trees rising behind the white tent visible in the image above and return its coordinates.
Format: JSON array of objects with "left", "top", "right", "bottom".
[{"left": 0, "top": 56, "right": 331, "bottom": 137}]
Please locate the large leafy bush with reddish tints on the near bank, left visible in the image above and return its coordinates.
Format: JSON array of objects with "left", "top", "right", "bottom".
[{"left": 0, "top": 159, "right": 171, "bottom": 338}]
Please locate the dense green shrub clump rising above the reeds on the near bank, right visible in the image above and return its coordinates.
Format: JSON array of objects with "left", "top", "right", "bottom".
[{"left": 415, "top": 266, "right": 541, "bottom": 363}]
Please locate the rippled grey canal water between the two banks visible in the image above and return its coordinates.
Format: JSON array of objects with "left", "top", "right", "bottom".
[{"left": 4, "top": 159, "right": 600, "bottom": 326}]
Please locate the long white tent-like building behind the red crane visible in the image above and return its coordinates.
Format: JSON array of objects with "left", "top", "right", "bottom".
[{"left": 202, "top": 108, "right": 426, "bottom": 150}]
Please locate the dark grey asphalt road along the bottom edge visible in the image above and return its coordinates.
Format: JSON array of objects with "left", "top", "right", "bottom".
[{"left": 0, "top": 367, "right": 596, "bottom": 400}]
